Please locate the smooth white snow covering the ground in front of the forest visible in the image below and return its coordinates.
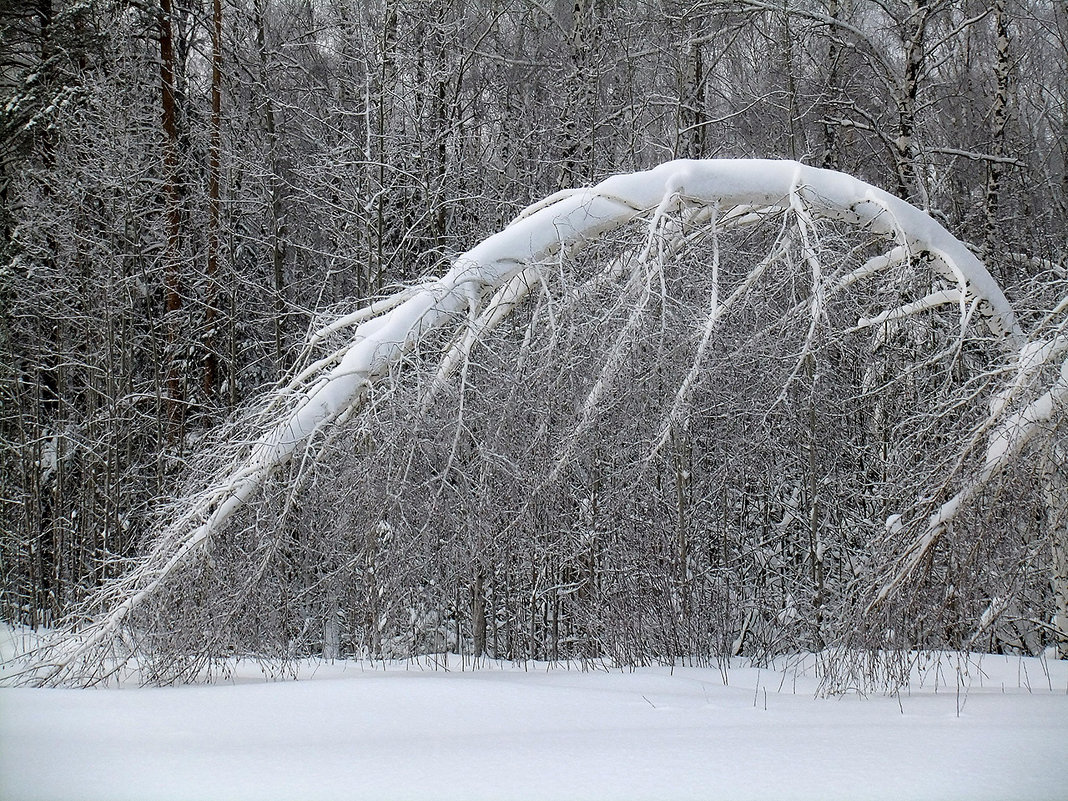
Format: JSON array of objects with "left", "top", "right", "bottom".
[{"left": 0, "top": 629, "right": 1068, "bottom": 801}]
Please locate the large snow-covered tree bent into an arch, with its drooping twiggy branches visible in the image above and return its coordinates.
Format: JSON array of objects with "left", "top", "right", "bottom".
[{"left": 18, "top": 160, "right": 1068, "bottom": 684}]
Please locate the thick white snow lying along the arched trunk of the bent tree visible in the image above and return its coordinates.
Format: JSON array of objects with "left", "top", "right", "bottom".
[{"left": 22, "top": 160, "right": 1023, "bottom": 681}]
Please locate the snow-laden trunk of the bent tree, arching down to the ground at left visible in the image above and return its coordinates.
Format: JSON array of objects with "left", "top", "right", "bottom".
[{"left": 12, "top": 160, "right": 1030, "bottom": 682}]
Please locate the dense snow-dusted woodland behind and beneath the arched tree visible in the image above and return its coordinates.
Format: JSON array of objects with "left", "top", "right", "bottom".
[{"left": 0, "top": 0, "right": 1068, "bottom": 676}]
